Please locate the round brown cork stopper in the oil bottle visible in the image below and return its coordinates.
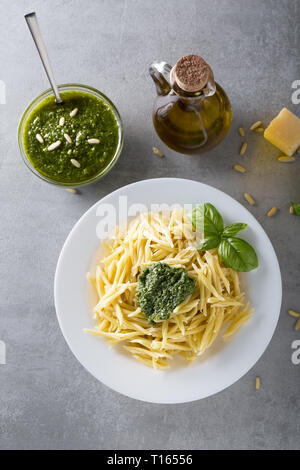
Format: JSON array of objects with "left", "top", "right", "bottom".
[{"left": 171, "top": 54, "right": 213, "bottom": 93}]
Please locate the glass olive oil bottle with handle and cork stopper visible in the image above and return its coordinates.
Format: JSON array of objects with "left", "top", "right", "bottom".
[{"left": 149, "top": 54, "right": 232, "bottom": 155}]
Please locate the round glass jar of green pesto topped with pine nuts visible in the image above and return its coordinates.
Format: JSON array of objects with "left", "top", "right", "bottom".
[{"left": 18, "top": 84, "right": 123, "bottom": 187}]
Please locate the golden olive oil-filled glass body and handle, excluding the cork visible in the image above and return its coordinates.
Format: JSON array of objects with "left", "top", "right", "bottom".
[{"left": 150, "top": 55, "right": 232, "bottom": 154}]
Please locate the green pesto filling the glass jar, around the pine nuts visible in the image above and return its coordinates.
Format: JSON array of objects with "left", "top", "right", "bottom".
[{"left": 23, "top": 91, "right": 119, "bottom": 183}]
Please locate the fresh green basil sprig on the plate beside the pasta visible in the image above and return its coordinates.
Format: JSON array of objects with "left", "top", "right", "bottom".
[{"left": 192, "top": 202, "right": 258, "bottom": 272}]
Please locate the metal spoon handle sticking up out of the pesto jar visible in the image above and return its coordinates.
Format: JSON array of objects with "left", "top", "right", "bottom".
[{"left": 25, "top": 12, "right": 63, "bottom": 104}]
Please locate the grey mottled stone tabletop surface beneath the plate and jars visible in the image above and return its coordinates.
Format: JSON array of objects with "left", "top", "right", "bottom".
[{"left": 0, "top": 0, "right": 300, "bottom": 449}]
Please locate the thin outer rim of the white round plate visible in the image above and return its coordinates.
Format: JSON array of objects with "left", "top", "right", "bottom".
[{"left": 54, "top": 177, "right": 282, "bottom": 404}]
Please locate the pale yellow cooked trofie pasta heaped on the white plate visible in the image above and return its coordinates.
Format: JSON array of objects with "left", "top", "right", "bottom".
[{"left": 86, "top": 209, "right": 252, "bottom": 369}]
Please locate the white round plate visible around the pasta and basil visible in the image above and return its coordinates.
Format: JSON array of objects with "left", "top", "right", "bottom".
[{"left": 54, "top": 178, "right": 282, "bottom": 403}]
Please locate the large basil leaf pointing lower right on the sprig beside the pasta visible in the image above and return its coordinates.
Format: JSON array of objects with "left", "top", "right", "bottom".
[{"left": 218, "top": 237, "right": 258, "bottom": 272}]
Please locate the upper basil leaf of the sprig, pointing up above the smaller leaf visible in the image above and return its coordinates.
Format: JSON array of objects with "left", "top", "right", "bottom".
[{"left": 192, "top": 202, "right": 224, "bottom": 238}]
